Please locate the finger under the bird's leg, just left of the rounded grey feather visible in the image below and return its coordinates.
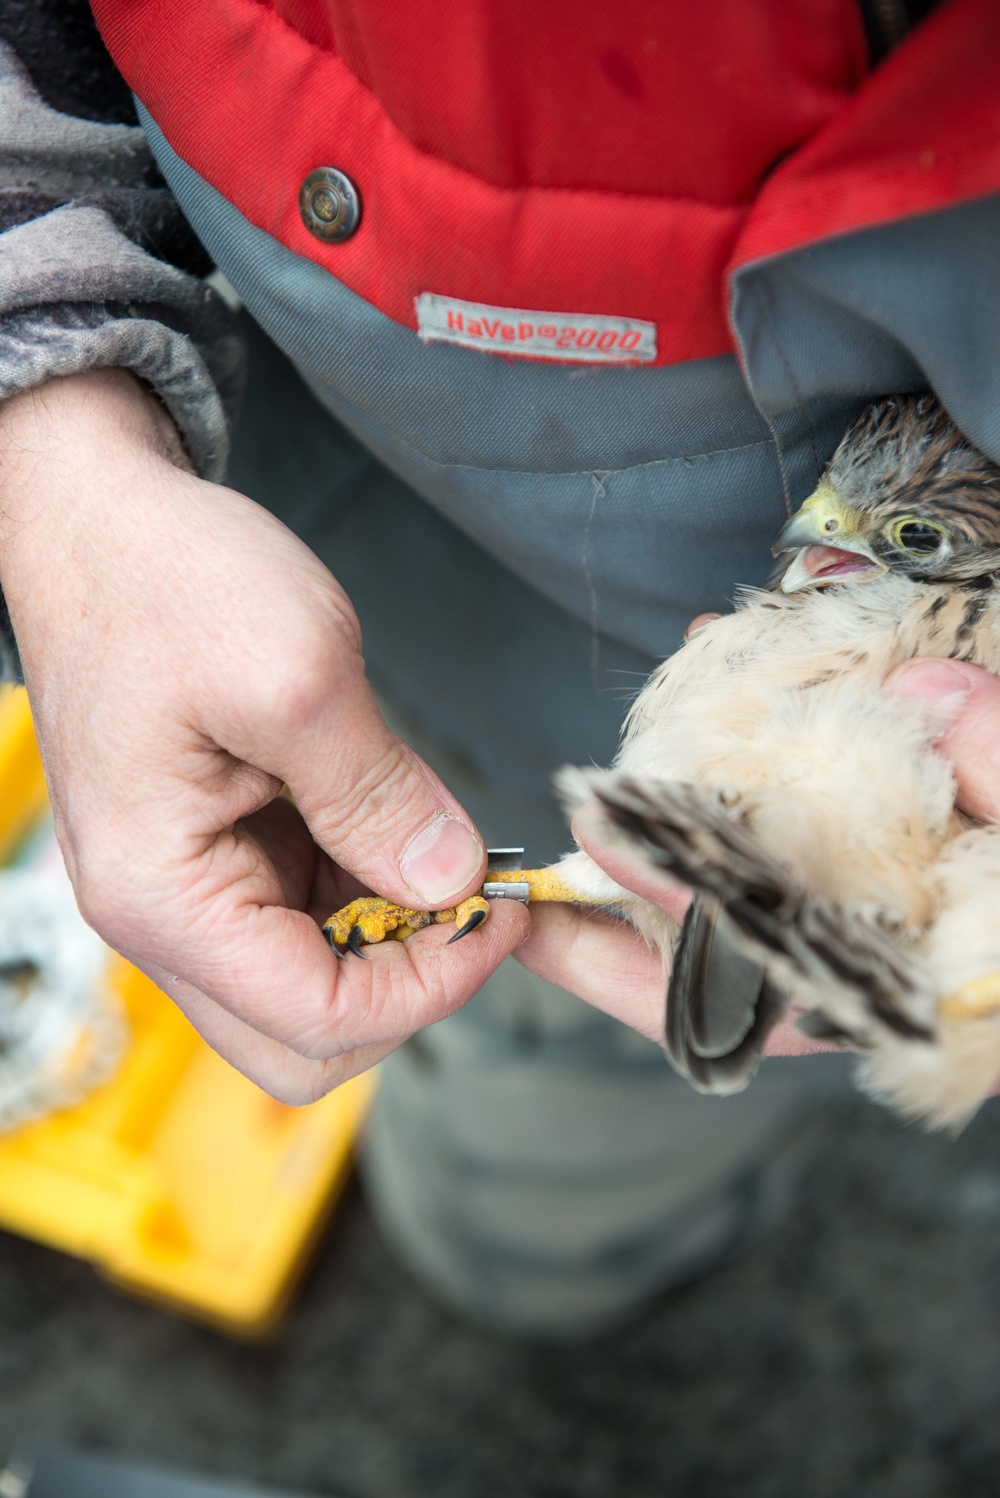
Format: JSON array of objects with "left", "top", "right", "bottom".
[{"left": 518, "top": 905, "right": 666, "bottom": 1043}]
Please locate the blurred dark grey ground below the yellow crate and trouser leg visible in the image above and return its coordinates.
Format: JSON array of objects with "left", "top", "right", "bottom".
[{"left": 0, "top": 1103, "right": 1000, "bottom": 1498}]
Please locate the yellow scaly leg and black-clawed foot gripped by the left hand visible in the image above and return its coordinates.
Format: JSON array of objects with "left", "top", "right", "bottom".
[{"left": 323, "top": 866, "right": 597, "bottom": 957}]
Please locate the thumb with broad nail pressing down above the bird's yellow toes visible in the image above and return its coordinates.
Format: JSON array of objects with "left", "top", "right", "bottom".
[{"left": 267, "top": 673, "right": 487, "bottom": 906}]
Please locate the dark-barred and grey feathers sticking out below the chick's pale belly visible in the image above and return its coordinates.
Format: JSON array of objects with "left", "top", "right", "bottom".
[{"left": 585, "top": 771, "right": 933, "bottom": 1092}]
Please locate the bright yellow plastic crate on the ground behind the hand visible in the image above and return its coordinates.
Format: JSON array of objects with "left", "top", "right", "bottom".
[{"left": 0, "top": 688, "right": 374, "bottom": 1338}]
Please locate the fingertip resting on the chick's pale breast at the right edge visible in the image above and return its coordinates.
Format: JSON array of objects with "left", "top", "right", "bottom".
[{"left": 885, "top": 661, "right": 1000, "bottom": 822}]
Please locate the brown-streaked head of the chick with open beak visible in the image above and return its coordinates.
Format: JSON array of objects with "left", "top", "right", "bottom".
[{"left": 774, "top": 395, "right": 1000, "bottom": 593}]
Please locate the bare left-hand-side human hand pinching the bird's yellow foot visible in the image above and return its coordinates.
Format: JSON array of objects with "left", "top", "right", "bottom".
[{"left": 0, "top": 370, "right": 528, "bottom": 1103}]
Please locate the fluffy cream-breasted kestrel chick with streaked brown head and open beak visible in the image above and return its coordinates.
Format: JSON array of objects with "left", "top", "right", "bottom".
[{"left": 560, "top": 395, "right": 1000, "bottom": 1126}]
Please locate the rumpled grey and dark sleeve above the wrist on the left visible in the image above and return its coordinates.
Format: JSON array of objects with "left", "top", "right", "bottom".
[{"left": 0, "top": 40, "right": 241, "bottom": 479}]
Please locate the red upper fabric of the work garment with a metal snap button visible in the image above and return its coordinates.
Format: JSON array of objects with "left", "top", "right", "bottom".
[{"left": 94, "top": 0, "right": 1000, "bottom": 364}]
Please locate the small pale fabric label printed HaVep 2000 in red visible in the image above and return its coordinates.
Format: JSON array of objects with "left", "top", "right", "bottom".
[{"left": 416, "top": 291, "right": 656, "bottom": 364}]
